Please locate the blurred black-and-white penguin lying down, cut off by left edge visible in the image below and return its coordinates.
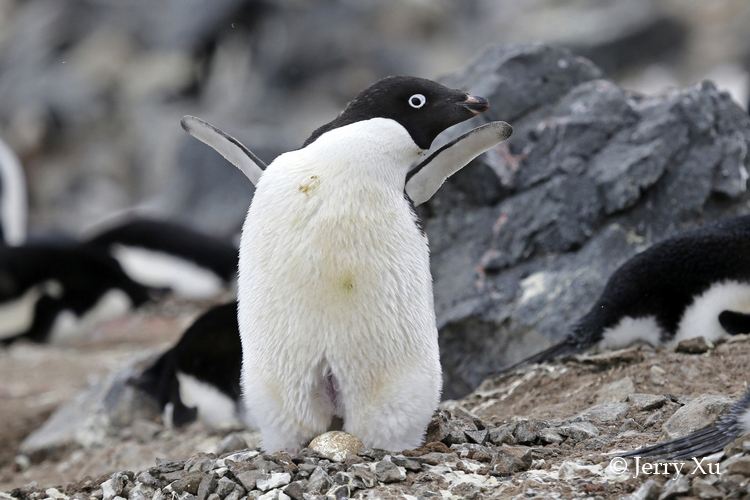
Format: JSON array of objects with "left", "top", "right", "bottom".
[{"left": 0, "top": 243, "right": 155, "bottom": 345}]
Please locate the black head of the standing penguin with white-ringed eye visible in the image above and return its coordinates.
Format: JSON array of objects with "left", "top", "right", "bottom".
[{"left": 304, "top": 76, "right": 489, "bottom": 149}]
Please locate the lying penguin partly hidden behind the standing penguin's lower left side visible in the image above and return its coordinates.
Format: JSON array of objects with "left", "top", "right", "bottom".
[{"left": 131, "top": 301, "right": 247, "bottom": 428}]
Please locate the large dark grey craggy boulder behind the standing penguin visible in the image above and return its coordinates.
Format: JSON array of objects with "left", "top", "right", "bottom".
[{"left": 432, "top": 45, "right": 750, "bottom": 398}]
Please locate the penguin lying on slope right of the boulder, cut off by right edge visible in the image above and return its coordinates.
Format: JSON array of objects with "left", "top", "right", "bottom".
[{"left": 503, "top": 216, "right": 750, "bottom": 371}]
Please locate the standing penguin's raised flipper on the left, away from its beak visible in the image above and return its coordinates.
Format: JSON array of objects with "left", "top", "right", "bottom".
[{"left": 180, "top": 115, "right": 266, "bottom": 185}]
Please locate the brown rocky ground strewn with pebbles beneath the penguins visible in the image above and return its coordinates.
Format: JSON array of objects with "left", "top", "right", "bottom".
[{"left": 0, "top": 306, "right": 750, "bottom": 500}]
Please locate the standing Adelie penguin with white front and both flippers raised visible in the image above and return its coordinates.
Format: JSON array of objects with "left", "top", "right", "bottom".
[{"left": 183, "top": 77, "right": 511, "bottom": 451}]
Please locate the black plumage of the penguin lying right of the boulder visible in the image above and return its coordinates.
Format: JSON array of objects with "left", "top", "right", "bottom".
[{"left": 503, "top": 216, "right": 750, "bottom": 371}]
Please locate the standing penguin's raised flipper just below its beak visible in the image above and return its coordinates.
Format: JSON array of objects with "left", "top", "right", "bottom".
[{"left": 406, "top": 122, "right": 513, "bottom": 206}]
